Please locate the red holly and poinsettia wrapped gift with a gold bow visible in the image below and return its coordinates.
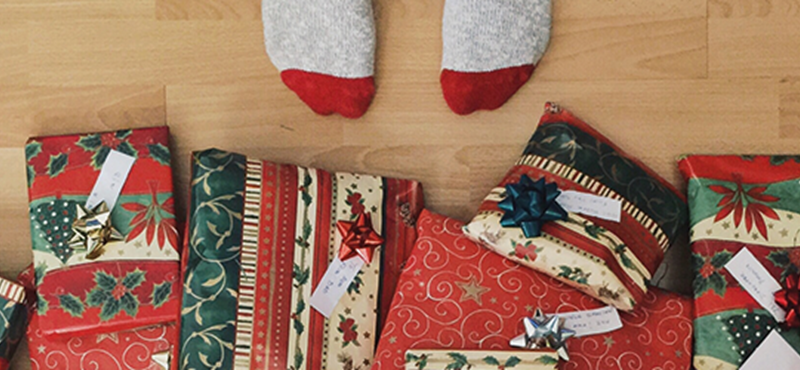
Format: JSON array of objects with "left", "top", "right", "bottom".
[{"left": 25, "top": 127, "right": 180, "bottom": 336}]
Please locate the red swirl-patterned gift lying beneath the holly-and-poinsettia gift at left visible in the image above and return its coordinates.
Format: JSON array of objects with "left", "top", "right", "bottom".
[{"left": 18, "top": 266, "right": 178, "bottom": 370}]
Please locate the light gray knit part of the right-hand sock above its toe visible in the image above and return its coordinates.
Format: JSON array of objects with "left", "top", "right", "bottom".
[{"left": 442, "top": 0, "right": 551, "bottom": 72}]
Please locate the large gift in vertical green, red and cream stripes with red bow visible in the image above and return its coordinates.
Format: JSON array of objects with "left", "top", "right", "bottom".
[{"left": 180, "top": 150, "right": 423, "bottom": 370}]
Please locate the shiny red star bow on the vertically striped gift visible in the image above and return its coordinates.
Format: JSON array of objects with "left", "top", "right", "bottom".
[{"left": 336, "top": 212, "right": 383, "bottom": 263}]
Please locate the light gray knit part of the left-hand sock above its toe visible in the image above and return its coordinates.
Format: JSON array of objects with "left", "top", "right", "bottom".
[{"left": 262, "top": 0, "right": 375, "bottom": 78}]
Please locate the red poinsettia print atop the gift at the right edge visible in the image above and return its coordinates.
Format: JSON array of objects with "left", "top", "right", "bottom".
[{"left": 708, "top": 176, "right": 780, "bottom": 240}]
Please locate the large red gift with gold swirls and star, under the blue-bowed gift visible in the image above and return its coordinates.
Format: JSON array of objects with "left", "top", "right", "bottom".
[{"left": 372, "top": 211, "right": 692, "bottom": 370}]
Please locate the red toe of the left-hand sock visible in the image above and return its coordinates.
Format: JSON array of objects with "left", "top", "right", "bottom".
[{"left": 281, "top": 69, "right": 375, "bottom": 118}]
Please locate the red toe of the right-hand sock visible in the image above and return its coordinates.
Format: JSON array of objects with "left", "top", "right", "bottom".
[{"left": 440, "top": 64, "right": 534, "bottom": 115}]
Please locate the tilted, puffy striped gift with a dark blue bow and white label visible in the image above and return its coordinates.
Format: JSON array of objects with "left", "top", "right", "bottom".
[{"left": 464, "top": 103, "right": 687, "bottom": 311}]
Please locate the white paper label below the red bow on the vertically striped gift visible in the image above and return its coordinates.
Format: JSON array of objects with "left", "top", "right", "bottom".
[{"left": 308, "top": 257, "right": 364, "bottom": 318}]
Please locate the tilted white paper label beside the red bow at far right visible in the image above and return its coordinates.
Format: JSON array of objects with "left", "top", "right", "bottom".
[{"left": 725, "top": 248, "right": 786, "bottom": 322}]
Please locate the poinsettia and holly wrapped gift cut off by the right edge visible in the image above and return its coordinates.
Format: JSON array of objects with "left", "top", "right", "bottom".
[{"left": 679, "top": 155, "right": 800, "bottom": 370}]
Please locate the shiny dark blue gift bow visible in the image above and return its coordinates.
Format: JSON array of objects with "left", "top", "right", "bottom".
[{"left": 498, "top": 175, "right": 567, "bottom": 238}]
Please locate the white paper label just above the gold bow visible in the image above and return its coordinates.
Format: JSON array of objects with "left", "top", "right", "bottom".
[{"left": 86, "top": 150, "right": 136, "bottom": 210}]
